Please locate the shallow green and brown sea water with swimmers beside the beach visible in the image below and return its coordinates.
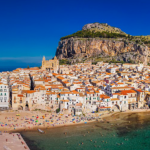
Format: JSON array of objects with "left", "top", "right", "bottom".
[{"left": 21, "top": 113, "right": 150, "bottom": 150}]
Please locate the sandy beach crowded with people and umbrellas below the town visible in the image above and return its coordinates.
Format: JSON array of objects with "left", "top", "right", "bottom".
[{"left": 0, "top": 109, "right": 150, "bottom": 132}]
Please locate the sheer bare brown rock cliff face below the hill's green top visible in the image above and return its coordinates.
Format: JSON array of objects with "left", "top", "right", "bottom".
[{"left": 56, "top": 38, "right": 148, "bottom": 65}]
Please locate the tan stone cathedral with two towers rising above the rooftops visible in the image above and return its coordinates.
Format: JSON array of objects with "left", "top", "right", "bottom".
[{"left": 42, "top": 56, "right": 59, "bottom": 71}]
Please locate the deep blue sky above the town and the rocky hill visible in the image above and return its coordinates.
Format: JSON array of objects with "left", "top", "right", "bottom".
[{"left": 0, "top": 0, "right": 150, "bottom": 71}]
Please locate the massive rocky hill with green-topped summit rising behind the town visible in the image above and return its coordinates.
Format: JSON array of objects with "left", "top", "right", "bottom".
[{"left": 56, "top": 23, "right": 150, "bottom": 65}]
